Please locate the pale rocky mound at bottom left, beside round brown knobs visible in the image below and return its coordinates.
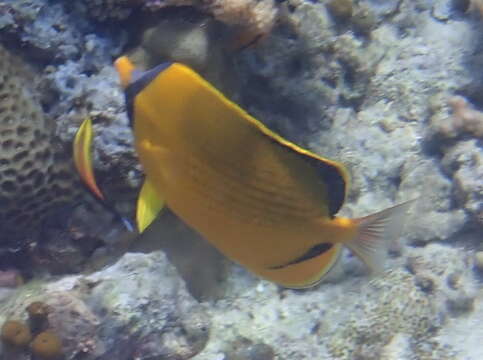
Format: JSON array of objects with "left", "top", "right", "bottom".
[{"left": 0, "top": 252, "right": 210, "bottom": 360}]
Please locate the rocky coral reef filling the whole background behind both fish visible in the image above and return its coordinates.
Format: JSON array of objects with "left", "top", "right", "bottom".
[{"left": 0, "top": 0, "right": 483, "bottom": 360}]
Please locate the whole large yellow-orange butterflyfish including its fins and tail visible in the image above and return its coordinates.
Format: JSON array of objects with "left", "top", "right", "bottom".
[{"left": 74, "top": 57, "right": 410, "bottom": 288}]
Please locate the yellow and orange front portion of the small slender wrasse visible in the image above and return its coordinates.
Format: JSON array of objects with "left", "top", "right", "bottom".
[{"left": 73, "top": 117, "right": 104, "bottom": 201}]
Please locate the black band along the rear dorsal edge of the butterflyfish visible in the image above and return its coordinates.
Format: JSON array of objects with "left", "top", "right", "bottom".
[{"left": 267, "top": 135, "right": 346, "bottom": 218}]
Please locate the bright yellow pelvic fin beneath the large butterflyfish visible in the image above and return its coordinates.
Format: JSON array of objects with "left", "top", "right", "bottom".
[{"left": 136, "top": 178, "right": 164, "bottom": 233}]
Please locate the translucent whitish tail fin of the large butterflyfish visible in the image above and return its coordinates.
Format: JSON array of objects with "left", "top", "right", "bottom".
[{"left": 346, "top": 200, "right": 415, "bottom": 272}]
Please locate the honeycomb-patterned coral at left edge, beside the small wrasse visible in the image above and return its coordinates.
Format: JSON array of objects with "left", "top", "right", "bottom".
[{"left": 0, "top": 48, "right": 79, "bottom": 247}]
